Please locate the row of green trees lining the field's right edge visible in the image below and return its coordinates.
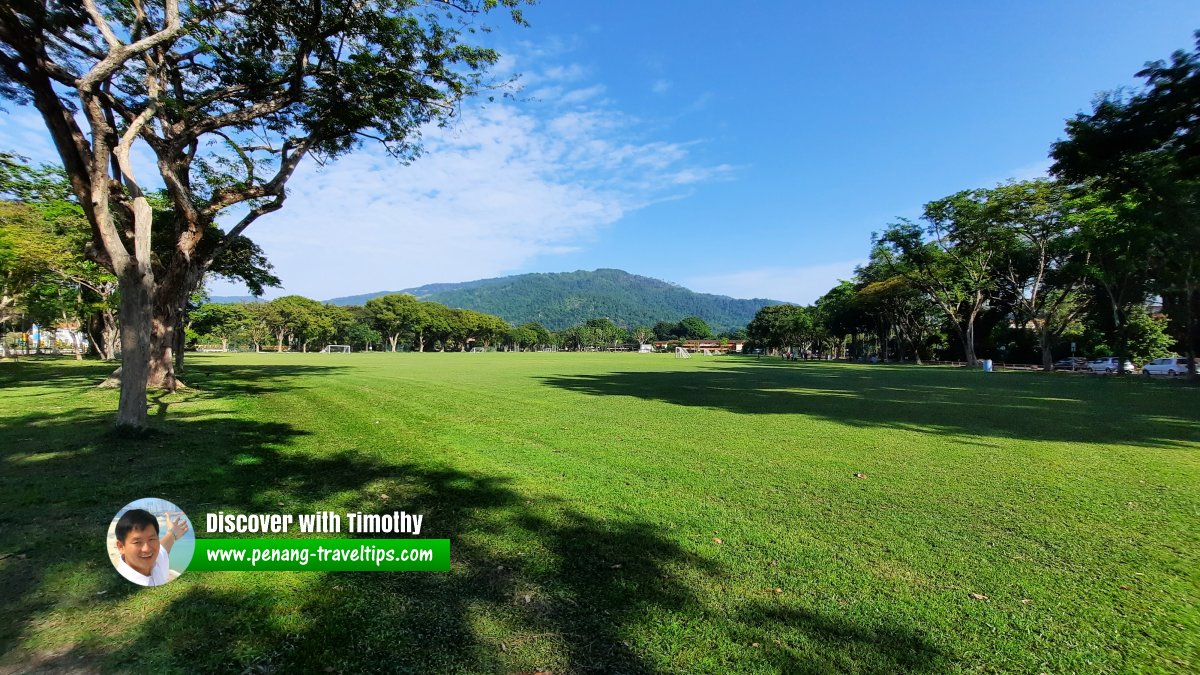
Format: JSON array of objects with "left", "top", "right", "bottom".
[{"left": 749, "top": 32, "right": 1200, "bottom": 378}]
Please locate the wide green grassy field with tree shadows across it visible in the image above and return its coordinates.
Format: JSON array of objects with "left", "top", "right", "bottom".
[{"left": 0, "top": 353, "right": 1200, "bottom": 674}]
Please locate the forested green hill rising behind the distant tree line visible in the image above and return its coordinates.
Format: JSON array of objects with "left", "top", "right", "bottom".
[{"left": 326, "top": 269, "right": 780, "bottom": 330}]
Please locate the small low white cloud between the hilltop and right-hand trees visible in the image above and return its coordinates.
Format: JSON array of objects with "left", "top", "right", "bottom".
[{"left": 684, "top": 258, "right": 866, "bottom": 304}]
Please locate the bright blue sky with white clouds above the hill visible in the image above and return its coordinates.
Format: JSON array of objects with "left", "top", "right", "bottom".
[{"left": 0, "top": 0, "right": 1200, "bottom": 303}]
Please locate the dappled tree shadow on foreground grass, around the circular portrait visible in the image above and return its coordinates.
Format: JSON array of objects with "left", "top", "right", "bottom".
[{"left": 0, "top": 401, "right": 948, "bottom": 673}]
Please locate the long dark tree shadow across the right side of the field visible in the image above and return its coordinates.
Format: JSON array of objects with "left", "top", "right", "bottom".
[{"left": 540, "top": 360, "right": 1200, "bottom": 448}]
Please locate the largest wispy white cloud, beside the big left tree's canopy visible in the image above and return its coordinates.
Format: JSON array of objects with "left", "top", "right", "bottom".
[{"left": 215, "top": 88, "right": 734, "bottom": 298}]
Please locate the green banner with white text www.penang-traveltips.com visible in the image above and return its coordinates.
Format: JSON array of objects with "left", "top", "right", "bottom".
[{"left": 187, "top": 538, "right": 450, "bottom": 572}]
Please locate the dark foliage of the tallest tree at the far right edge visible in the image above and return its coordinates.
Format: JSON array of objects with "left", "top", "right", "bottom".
[{"left": 1051, "top": 31, "right": 1200, "bottom": 375}]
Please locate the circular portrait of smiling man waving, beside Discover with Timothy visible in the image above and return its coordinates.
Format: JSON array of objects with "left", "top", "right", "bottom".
[{"left": 107, "top": 497, "right": 196, "bottom": 586}]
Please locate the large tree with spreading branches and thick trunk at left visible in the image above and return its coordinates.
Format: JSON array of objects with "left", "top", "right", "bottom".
[{"left": 0, "top": 0, "right": 522, "bottom": 428}]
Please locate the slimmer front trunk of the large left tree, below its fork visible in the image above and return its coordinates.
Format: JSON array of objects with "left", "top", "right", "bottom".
[{"left": 116, "top": 264, "right": 154, "bottom": 429}]
